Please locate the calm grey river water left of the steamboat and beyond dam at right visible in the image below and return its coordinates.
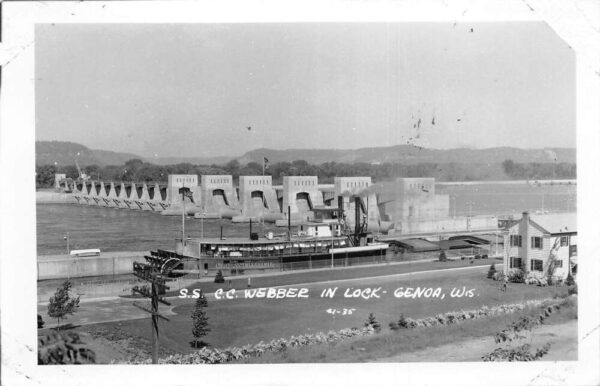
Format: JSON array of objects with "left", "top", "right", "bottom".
[{"left": 37, "top": 184, "right": 577, "bottom": 255}]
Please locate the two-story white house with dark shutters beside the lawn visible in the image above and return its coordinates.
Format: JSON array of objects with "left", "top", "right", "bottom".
[{"left": 504, "top": 212, "right": 577, "bottom": 279}]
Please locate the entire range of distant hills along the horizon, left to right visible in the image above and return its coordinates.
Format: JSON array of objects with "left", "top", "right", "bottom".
[{"left": 36, "top": 141, "right": 577, "bottom": 166}]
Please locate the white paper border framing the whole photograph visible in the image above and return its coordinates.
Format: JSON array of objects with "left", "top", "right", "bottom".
[{"left": 0, "top": 0, "right": 600, "bottom": 385}]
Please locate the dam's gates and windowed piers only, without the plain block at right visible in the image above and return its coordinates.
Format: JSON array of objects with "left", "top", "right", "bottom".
[{"left": 55, "top": 174, "right": 381, "bottom": 228}]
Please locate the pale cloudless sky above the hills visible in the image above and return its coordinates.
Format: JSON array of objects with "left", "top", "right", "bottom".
[{"left": 35, "top": 22, "right": 576, "bottom": 157}]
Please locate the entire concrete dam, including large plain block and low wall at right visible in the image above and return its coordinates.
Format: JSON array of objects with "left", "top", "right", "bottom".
[{"left": 55, "top": 174, "right": 497, "bottom": 235}]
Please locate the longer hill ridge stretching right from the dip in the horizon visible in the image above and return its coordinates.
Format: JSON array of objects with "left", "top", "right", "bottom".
[{"left": 238, "top": 145, "right": 577, "bottom": 164}]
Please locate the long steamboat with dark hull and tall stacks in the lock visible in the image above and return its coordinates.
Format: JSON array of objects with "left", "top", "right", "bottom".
[{"left": 151, "top": 196, "right": 389, "bottom": 275}]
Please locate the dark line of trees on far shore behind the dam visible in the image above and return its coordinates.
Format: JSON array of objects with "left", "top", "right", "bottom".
[{"left": 36, "top": 159, "right": 577, "bottom": 188}]
